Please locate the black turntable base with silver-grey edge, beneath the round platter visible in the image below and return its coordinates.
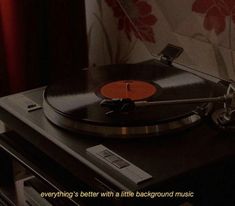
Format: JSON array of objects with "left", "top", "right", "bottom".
[{"left": 0, "top": 88, "right": 235, "bottom": 205}]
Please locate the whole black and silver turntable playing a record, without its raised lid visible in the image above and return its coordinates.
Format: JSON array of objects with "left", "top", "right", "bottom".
[{"left": 0, "top": 2, "right": 235, "bottom": 205}]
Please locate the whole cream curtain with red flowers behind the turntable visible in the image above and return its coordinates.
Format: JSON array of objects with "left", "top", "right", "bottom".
[{"left": 87, "top": 0, "right": 235, "bottom": 80}]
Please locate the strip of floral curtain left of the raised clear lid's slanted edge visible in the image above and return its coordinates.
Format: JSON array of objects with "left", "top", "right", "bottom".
[{"left": 86, "top": 0, "right": 153, "bottom": 66}]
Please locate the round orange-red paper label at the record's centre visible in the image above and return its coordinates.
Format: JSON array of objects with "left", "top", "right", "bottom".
[{"left": 100, "top": 80, "right": 157, "bottom": 101}]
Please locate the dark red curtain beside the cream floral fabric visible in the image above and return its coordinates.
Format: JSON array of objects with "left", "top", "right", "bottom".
[{"left": 0, "top": 0, "right": 88, "bottom": 95}]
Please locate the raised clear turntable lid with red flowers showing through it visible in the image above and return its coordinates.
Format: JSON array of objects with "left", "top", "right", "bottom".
[{"left": 119, "top": 0, "right": 235, "bottom": 80}]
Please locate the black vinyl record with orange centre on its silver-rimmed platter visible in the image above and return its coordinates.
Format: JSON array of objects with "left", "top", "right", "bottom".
[{"left": 43, "top": 63, "right": 217, "bottom": 137}]
